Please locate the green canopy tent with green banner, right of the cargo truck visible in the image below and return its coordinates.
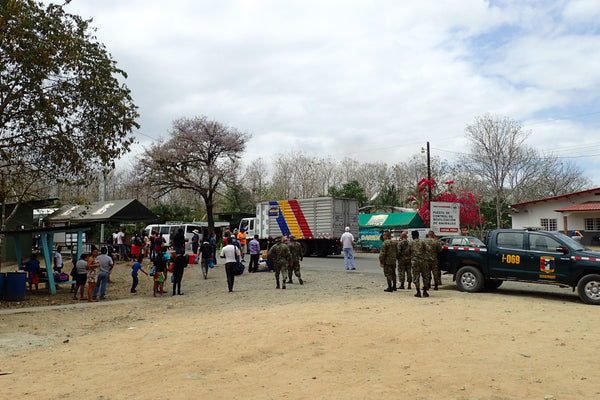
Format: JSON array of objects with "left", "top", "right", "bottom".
[{"left": 358, "top": 212, "right": 426, "bottom": 249}]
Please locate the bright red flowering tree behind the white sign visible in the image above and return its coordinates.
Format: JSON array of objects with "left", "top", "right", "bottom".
[{"left": 410, "top": 178, "right": 485, "bottom": 227}]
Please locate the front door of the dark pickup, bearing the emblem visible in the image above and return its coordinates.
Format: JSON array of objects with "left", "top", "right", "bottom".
[{"left": 527, "top": 232, "right": 573, "bottom": 282}]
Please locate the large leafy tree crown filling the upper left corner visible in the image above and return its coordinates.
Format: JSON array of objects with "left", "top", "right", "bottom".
[{"left": 0, "top": 0, "right": 138, "bottom": 226}]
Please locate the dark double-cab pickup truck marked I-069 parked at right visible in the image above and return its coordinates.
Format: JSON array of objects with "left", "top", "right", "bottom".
[{"left": 440, "top": 229, "right": 600, "bottom": 305}]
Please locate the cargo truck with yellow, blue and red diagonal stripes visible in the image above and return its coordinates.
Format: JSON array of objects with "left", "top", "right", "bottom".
[{"left": 239, "top": 197, "right": 358, "bottom": 256}]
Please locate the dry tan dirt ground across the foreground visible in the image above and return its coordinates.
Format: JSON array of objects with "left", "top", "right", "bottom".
[{"left": 0, "top": 261, "right": 600, "bottom": 400}]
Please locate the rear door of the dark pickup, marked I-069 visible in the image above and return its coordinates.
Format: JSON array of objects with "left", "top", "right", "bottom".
[{"left": 488, "top": 231, "right": 538, "bottom": 279}]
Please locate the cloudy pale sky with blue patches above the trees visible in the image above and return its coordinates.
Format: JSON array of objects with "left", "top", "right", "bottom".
[{"left": 57, "top": 0, "right": 600, "bottom": 186}]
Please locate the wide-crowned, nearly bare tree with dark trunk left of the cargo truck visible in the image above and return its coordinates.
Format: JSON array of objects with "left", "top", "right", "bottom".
[{"left": 137, "top": 117, "right": 251, "bottom": 232}]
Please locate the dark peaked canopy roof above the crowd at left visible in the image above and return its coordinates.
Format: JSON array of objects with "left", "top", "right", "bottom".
[{"left": 45, "top": 199, "right": 159, "bottom": 226}]
